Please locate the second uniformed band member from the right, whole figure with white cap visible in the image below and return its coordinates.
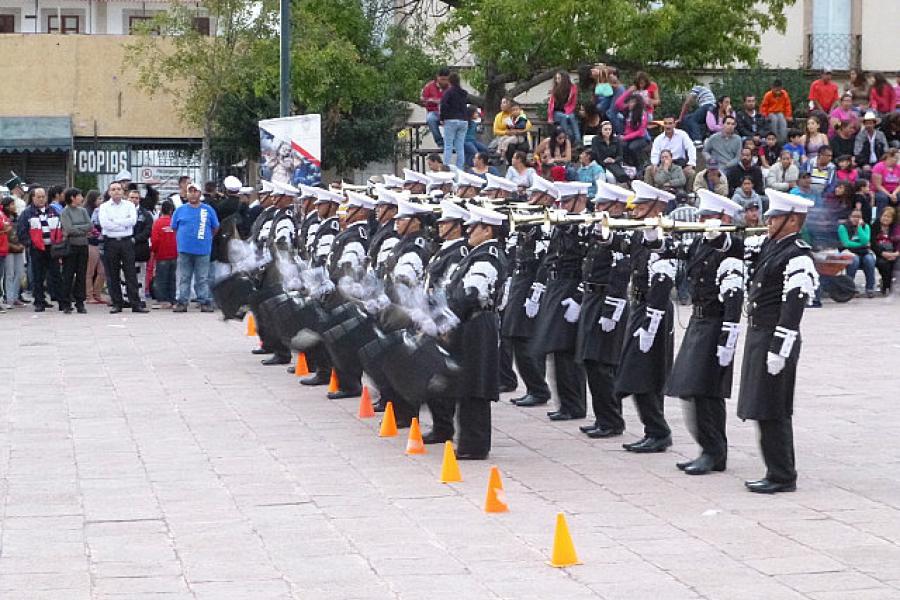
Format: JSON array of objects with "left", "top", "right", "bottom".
[{"left": 666, "top": 189, "right": 744, "bottom": 475}]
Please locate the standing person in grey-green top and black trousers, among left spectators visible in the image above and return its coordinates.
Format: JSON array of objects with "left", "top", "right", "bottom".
[{"left": 59, "top": 188, "right": 94, "bottom": 315}]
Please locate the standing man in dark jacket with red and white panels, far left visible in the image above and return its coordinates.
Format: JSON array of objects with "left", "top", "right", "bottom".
[{"left": 17, "top": 185, "right": 62, "bottom": 312}]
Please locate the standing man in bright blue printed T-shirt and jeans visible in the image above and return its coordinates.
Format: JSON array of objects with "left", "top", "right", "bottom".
[{"left": 172, "top": 183, "right": 219, "bottom": 312}]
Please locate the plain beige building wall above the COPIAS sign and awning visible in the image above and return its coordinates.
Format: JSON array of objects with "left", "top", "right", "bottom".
[{"left": 0, "top": 34, "right": 201, "bottom": 138}]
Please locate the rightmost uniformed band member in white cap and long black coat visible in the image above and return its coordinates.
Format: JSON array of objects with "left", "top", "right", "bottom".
[{"left": 737, "top": 190, "right": 819, "bottom": 494}]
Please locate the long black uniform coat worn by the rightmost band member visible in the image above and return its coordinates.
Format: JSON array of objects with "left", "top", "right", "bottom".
[{"left": 738, "top": 234, "right": 818, "bottom": 421}]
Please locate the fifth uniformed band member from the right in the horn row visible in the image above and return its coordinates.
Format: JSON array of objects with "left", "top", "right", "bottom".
[{"left": 526, "top": 181, "right": 590, "bottom": 421}]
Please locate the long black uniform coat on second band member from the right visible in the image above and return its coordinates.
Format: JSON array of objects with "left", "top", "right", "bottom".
[{"left": 666, "top": 233, "right": 744, "bottom": 398}]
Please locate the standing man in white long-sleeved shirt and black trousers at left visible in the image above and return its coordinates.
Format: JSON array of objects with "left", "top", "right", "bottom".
[{"left": 97, "top": 182, "right": 149, "bottom": 313}]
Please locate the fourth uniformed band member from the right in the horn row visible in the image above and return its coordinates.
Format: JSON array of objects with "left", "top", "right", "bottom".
[{"left": 575, "top": 181, "right": 631, "bottom": 438}]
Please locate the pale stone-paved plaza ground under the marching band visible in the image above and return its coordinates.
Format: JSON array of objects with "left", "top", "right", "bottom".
[{"left": 0, "top": 299, "right": 900, "bottom": 600}]
